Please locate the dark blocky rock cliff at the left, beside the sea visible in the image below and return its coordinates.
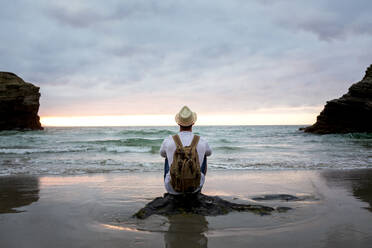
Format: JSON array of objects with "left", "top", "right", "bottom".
[{"left": 0, "top": 72, "right": 43, "bottom": 130}]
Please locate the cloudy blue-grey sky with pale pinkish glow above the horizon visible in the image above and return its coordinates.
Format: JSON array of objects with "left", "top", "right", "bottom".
[{"left": 0, "top": 0, "right": 372, "bottom": 125}]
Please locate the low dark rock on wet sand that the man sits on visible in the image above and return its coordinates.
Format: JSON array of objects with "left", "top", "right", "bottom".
[{"left": 133, "top": 193, "right": 290, "bottom": 219}]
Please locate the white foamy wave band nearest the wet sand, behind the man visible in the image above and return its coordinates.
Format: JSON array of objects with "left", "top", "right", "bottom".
[{"left": 0, "top": 159, "right": 371, "bottom": 176}]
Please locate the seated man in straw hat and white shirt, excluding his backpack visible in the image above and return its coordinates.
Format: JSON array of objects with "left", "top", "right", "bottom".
[{"left": 160, "top": 106, "right": 212, "bottom": 195}]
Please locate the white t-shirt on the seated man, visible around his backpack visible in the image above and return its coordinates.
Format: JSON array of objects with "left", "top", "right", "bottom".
[{"left": 160, "top": 131, "right": 212, "bottom": 195}]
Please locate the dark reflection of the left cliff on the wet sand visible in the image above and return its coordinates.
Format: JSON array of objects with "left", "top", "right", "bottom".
[{"left": 0, "top": 176, "right": 39, "bottom": 214}]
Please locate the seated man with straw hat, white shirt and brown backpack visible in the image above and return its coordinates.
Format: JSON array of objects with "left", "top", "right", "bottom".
[{"left": 160, "top": 106, "right": 212, "bottom": 195}]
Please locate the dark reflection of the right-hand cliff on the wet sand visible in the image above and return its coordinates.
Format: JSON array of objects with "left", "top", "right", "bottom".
[{"left": 321, "top": 169, "right": 372, "bottom": 212}]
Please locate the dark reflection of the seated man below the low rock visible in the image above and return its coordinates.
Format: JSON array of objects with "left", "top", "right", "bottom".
[{"left": 164, "top": 215, "right": 208, "bottom": 248}]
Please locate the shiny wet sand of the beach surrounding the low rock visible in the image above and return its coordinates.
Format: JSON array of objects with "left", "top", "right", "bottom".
[{"left": 0, "top": 169, "right": 372, "bottom": 248}]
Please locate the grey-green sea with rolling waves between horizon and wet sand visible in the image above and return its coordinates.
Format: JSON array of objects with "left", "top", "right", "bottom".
[{"left": 0, "top": 126, "right": 372, "bottom": 176}]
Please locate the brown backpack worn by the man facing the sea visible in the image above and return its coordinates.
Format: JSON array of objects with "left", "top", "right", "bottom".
[{"left": 170, "top": 134, "right": 201, "bottom": 193}]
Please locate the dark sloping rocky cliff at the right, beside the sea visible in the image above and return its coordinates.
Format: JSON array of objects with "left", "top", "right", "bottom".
[{"left": 304, "top": 65, "right": 372, "bottom": 134}]
